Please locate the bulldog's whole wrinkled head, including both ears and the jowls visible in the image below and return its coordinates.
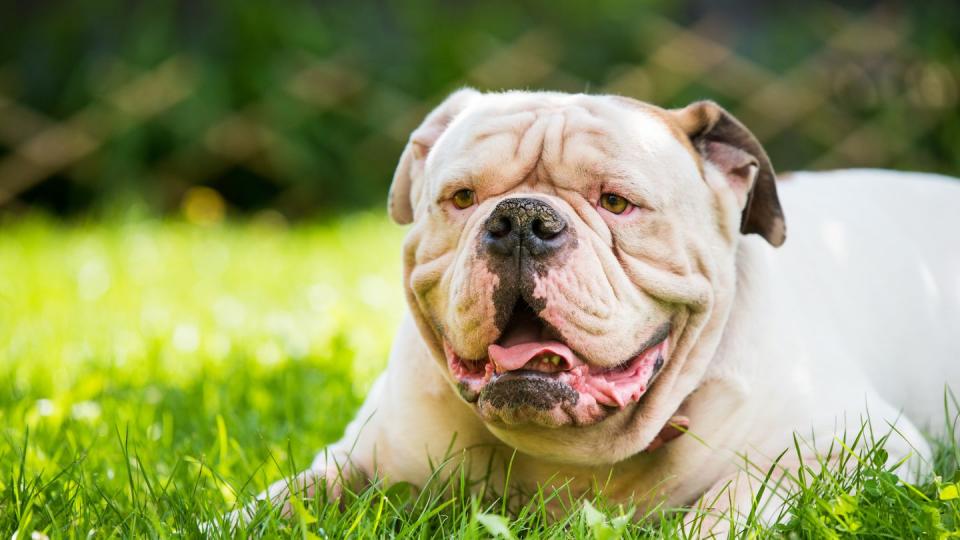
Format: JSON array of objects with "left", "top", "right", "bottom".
[{"left": 390, "top": 90, "right": 783, "bottom": 463}]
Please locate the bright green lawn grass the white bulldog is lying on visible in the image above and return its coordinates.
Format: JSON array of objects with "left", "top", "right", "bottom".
[{"left": 0, "top": 216, "right": 960, "bottom": 539}]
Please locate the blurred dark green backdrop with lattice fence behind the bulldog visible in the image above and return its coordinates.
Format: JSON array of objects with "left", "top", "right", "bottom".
[{"left": 0, "top": 0, "right": 960, "bottom": 223}]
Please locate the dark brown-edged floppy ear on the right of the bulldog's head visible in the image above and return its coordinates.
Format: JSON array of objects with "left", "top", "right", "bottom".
[{"left": 670, "top": 101, "right": 786, "bottom": 246}]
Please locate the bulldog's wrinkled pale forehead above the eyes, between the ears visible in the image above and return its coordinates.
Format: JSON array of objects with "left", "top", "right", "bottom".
[{"left": 426, "top": 93, "right": 699, "bottom": 192}]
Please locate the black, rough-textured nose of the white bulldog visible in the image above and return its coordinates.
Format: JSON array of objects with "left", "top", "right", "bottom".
[{"left": 483, "top": 198, "right": 568, "bottom": 257}]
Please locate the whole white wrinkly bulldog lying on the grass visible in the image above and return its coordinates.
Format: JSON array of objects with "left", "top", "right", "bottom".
[{"left": 251, "top": 89, "right": 960, "bottom": 532}]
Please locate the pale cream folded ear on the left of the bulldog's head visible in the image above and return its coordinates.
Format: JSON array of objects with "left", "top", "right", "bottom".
[{"left": 387, "top": 88, "right": 480, "bottom": 225}]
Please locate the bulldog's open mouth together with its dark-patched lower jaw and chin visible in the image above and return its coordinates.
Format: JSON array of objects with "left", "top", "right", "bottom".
[{"left": 443, "top": 299, "right": 672, "bottom": 429}]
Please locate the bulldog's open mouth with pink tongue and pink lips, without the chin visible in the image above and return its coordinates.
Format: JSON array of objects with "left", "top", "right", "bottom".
[{"left": 444, "top": 300, "right": 671, "bottom": 408}]
